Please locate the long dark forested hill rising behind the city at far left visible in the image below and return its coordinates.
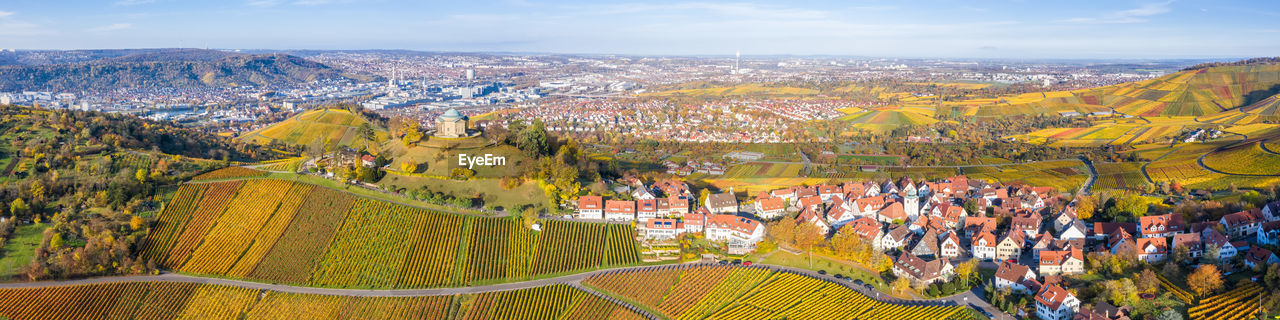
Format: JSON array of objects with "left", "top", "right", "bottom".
[{"left": 0, "top": 49, "right": 346, "bottom": 92}]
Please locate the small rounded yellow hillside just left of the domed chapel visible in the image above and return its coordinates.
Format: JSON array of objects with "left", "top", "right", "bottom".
[{"left": 237, "top": 109, "right": 388, "bottom": 146}]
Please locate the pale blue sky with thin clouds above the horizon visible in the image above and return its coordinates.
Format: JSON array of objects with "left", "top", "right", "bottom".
[{"left": 0, "top": 0, "right": 1280, "bottom": 59}]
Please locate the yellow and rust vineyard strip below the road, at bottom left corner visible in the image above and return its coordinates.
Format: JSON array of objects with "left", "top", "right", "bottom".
[{"left": 0, "top": 282, "right": 644, "bottom": 320}]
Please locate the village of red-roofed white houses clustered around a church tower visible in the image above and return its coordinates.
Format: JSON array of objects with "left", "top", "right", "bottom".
[{"left": 572, "top": 175, "right": 1280, "bottom": 320}]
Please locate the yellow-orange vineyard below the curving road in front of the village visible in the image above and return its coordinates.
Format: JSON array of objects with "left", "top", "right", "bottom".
[{"left": 584, "top": 265, "right": 973, "bottom": 319}]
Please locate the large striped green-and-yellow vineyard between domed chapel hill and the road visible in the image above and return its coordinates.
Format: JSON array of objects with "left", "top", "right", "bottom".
[{"left": 142, "top": 179, "right": 640, "bottom": 288}]
